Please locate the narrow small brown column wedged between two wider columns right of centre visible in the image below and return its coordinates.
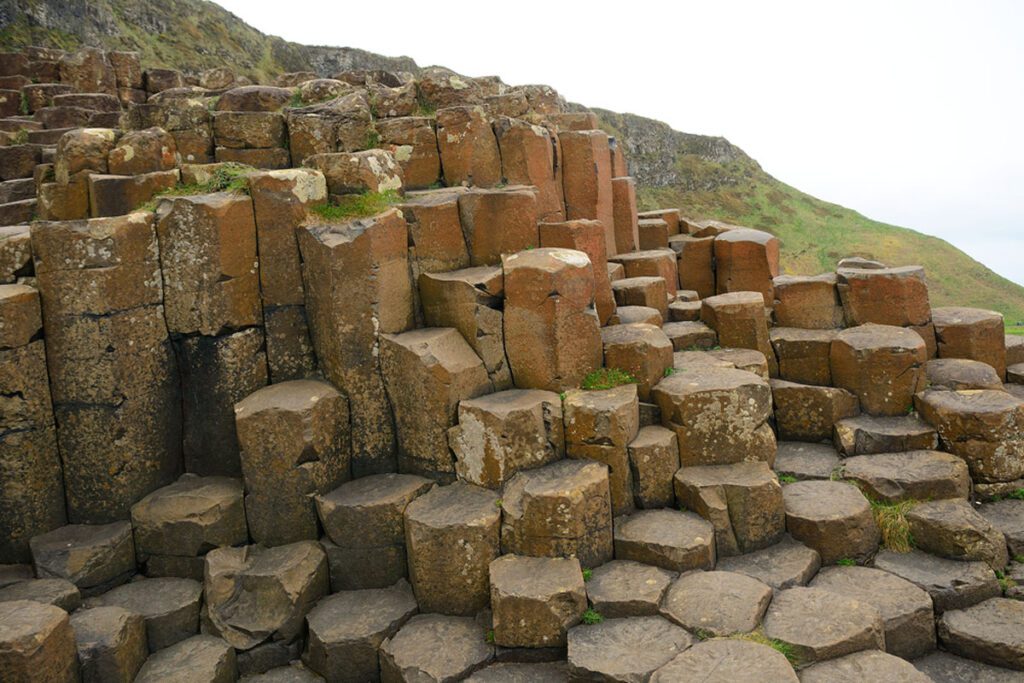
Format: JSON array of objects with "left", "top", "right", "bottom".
[{"left": 629, "top": 425, "right": 679, "bottom": 509}]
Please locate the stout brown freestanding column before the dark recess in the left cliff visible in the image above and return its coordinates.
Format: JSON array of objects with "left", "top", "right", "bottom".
[{"left": 234, "top": 380, "right": 351, "bottom": 545}]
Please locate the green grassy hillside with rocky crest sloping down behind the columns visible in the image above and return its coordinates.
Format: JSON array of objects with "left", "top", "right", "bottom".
[{"left": 599, "top": 112, "right": 1024, "bottom": 325}]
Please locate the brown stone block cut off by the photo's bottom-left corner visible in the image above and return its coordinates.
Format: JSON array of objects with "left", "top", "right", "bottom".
[{"left": 0, "top": 600, "right": 79, "bottom": 683}]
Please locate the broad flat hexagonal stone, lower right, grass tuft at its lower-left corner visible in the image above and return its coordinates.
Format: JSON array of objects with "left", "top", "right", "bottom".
[{"left": 764, "top": 588, "right": 886, "bottom": 665}]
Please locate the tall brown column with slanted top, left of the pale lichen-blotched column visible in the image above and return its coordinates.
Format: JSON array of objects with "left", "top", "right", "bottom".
[{"left": 380, "top": 328, "right": 492, "bottom": 481}]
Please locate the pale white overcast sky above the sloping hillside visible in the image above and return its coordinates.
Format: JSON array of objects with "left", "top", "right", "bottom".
[{"left": 218, "top": 0, "right": 1024, "bottom": 284}]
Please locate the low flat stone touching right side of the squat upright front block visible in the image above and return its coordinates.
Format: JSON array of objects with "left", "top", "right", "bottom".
[{"left": 587, "top": 560, "right": 676, "bottom": 618}]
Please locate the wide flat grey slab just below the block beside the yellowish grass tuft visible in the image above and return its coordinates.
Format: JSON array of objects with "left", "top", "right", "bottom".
[{"left": 874, "top": 550, "right": 1001, "bottom": 613}]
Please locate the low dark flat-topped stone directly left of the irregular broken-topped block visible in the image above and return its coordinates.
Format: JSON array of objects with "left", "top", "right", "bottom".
[{"left": 99, "top": 579, "right": 203, "bottom": 652}]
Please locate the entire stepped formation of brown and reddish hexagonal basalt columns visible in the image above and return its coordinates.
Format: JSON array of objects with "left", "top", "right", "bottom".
[{"left": 0, "top": 36, "right": 1024, "bottom": 683}]
